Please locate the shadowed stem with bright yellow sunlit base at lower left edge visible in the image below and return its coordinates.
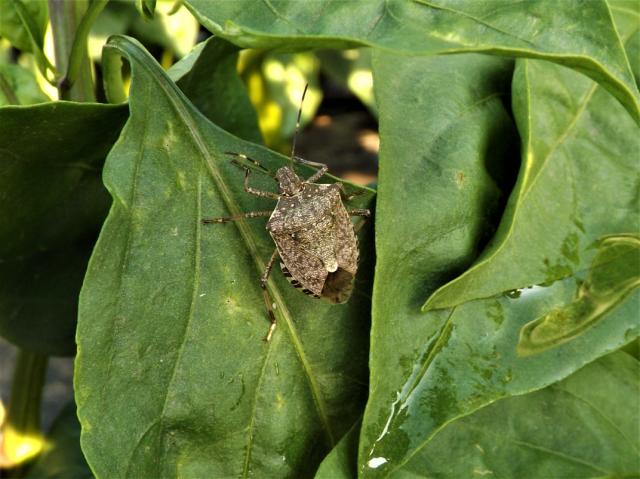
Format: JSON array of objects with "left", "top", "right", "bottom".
[{"left": 0, "top": 350, "right": 48, "bottom": 469}]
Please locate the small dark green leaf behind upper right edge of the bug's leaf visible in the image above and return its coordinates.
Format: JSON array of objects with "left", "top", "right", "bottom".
[{"left": 168, "top": 37, "right": 262, "bottom": 143}]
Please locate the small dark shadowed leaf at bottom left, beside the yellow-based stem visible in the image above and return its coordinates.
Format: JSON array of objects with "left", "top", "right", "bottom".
[{"left": 25, "top": 402, "right": 93, "bottom": 479}]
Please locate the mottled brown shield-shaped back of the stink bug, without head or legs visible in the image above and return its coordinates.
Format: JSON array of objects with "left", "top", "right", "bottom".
[{"left": 267, "top": 184, "right": 358, "bottom": 303}]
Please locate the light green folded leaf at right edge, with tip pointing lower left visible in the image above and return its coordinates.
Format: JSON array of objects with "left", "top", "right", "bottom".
[{"left": 425, "top": 25, "right": 640, "bottom": 309}]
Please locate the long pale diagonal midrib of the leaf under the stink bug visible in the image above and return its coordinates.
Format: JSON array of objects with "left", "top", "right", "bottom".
[{"left": 129, "top": 39, "right": 335, "bottom": 447}]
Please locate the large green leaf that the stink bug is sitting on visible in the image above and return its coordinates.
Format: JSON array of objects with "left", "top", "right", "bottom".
[{"left": 75, "top": 37, "right": 372, "bottom": 478}]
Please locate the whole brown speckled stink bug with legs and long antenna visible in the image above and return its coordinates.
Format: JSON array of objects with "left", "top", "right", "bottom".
[{"left": 202, "top": 86, "right": 370, "bottom": 341}]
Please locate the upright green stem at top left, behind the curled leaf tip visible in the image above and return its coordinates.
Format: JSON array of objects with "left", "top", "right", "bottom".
[{"left": 49, "top": 0, "right": 95, "bottom": 102}]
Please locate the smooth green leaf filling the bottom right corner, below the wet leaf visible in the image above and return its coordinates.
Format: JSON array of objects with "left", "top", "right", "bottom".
[{"left": 405, "top": 352, "right": 640, "bottom": 479}]
